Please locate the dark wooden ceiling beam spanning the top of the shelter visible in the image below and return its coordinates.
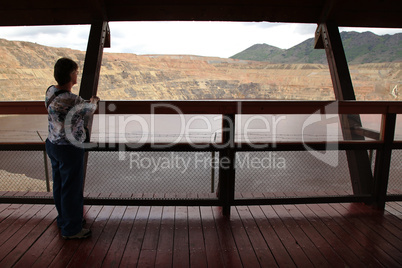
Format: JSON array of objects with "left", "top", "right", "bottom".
[{"left": 0, "top": 0, "right": 402, "bottom": 28}]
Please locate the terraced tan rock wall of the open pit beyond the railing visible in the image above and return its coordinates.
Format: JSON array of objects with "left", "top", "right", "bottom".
[{"left": 0, "top": 39, "right": 402, "bottom": 101}]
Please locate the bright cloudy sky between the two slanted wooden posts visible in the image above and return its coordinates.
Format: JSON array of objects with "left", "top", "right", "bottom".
[{"left": 109, "top": 22, "right": 316, "bottom": 57}]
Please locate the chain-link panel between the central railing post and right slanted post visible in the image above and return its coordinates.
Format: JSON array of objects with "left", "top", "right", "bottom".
[{"left": 236, "top": 151, "right": 352, "bottom": 196}]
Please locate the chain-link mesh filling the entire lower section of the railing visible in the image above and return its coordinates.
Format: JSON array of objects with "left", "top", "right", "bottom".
[{"left": 0, "top": 150, "right": 402, "bottom": 196}]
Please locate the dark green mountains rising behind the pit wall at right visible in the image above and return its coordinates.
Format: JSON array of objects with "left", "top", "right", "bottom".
[{"left": 230, "top": 32, "right": 402, "bottom": 64}]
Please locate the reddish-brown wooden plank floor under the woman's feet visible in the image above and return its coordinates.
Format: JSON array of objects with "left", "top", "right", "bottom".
[{"left": 0, "top": 202, "right": 402, "bottom": 267}]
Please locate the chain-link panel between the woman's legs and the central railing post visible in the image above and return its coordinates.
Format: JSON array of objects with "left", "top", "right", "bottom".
[{"left": 85, "top": 151, "right": 219, "bottom": 194}]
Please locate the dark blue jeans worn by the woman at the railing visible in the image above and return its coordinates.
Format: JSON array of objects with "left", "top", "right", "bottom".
[{"left": 46, "top": 140, "right": 84, "bottom": 236}]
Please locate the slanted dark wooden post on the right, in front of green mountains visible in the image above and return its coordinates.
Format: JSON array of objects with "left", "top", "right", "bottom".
[{"left": 316, "top": 22, "right": 373, "bottom": 194}]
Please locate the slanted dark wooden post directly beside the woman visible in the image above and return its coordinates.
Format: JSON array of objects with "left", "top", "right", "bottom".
[{"left": 79, "top": 20, "right": 109, "bottom": 191}]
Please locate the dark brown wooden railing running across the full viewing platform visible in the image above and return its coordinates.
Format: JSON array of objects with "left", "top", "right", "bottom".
[{"left": 0, "top": 101, "right": 402, "bottom": 214}]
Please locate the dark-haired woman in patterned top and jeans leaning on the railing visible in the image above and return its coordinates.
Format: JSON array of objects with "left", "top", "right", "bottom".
[{"left": 45, "top": 58, "right": 99, "bottom": 239}]
